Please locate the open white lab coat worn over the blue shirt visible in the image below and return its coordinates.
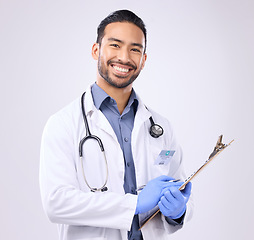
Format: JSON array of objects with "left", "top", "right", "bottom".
[{"left": 40, "top": 88, "right": 192, "bottom": 240}]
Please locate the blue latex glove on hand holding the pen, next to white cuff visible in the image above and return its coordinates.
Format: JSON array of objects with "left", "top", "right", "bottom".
[{"left": 135, "top": 175, "right": 182, "bottom": 214}]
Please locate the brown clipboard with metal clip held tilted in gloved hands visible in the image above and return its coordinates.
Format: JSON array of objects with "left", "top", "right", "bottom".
[{"left": 139, "top": 135, "right": 234, "bottom": 230}]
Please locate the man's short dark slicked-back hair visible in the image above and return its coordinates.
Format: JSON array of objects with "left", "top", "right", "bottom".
[{"left": 96, "top": 10, "right": 147, "bottom": 52}]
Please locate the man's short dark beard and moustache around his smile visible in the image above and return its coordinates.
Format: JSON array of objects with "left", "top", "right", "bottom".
[{"left": 98, "top": 56, "right": 141, "bottom": 88}]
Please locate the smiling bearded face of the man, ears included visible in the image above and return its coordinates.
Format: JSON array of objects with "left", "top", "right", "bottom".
[{"left": 93, "top": 22, "right": 146, "bottom": 88}]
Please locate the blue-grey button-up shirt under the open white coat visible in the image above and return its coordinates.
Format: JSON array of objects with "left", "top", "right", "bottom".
[{"left": 92, "top": 83, "right": 143, "bottom": 240}]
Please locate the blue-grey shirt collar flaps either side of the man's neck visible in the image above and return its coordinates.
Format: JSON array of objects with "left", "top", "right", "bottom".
[{"left": 91, "top": 83, "right": 138, "bottom": 112}]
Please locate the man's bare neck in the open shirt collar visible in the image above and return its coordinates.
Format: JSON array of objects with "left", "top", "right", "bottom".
[{"left": 96, "top": 80, "right": 132, "bottom": 114}]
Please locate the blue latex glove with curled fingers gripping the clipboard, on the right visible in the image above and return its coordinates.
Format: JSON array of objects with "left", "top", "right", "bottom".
[{"left": 158, "top": 182, "right": 192, "bottom": 219}]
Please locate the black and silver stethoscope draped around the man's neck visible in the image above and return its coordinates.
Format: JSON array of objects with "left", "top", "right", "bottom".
[{"left": 79, "top": 92, "right": 163, "bottom": 192}]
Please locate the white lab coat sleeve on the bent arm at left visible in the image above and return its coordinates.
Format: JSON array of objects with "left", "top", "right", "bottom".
[{"left": 40, "top": 115, "right": 137, "bottom": 230}]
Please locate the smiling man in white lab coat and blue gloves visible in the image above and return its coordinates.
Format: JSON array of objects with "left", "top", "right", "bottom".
[{"left": 40, "top": 10, "right": 192, "bottom": 240}]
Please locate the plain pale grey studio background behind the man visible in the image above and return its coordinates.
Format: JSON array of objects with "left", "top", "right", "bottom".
[{"left": 0, "top": 0, "right": 254, "bottom": 240}]
